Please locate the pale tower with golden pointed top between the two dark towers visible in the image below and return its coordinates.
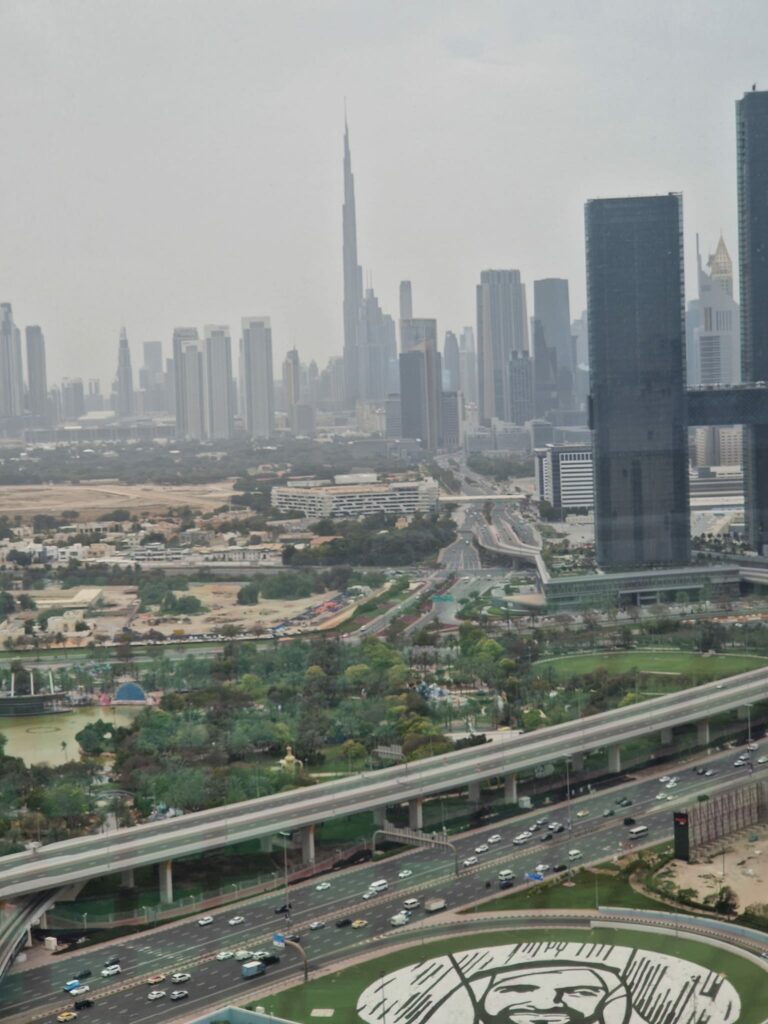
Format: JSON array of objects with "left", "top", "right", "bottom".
[{"left": 686, "top": 236, "right": 741, "bottom": 387}]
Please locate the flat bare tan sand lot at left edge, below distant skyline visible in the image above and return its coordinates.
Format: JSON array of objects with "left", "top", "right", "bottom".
[{"left": 0, "top": 480, "right": 232, "bottom": 521}]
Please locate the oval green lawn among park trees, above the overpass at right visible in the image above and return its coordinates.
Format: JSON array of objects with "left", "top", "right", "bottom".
[{"left": 535, "top": 650, "right": 768, "bottom": 683}]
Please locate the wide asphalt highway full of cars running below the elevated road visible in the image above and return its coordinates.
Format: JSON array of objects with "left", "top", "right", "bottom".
[{"left": 0, "top": 753, "right": 768, "bottom": 1024}]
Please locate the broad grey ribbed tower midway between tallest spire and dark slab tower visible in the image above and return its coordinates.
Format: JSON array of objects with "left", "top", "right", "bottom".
[{"left": 477, "top": 270, "right": 528, "bottom": 423}]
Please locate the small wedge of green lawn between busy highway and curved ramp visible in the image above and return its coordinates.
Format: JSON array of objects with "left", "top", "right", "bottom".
[{"left": 466, "top": 869, "right": 670, "bottom": 913}]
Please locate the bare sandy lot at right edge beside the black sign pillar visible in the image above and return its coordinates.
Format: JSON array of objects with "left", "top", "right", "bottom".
[{"left": 673, "top": 825, "right": 768, "bottom": 909}]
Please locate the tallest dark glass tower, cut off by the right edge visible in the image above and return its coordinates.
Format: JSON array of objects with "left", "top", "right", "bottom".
[{"left": 736, "top": 91, "right": 768, "bottom": 553}]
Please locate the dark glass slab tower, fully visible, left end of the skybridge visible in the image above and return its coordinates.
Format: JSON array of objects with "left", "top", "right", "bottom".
[{"left": 586, "top": 194, "right": 689, "bottom": 568}]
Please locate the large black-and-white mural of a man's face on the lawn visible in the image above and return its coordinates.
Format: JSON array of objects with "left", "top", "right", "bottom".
[{"left": 357, "top": 942, "right": 741, "bottom": 1024}]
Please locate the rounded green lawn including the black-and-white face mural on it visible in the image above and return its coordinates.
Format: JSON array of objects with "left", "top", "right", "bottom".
[{"left": 260, "top": 928, "right": 768, "bottom": 1024}]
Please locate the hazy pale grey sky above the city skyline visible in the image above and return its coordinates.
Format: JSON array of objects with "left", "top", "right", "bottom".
[{"left": 0, "top": 0, "right": 768, "bottom": 387}]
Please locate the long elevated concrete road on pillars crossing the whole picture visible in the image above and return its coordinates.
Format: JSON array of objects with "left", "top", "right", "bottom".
[{"left": 0, "top": 669, "right": 768, "bottom": 901}]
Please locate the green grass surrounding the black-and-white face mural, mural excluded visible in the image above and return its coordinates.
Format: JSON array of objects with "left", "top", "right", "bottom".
[{"left": 259, "top": 928, "right": 768, "bottom": 1024}]
